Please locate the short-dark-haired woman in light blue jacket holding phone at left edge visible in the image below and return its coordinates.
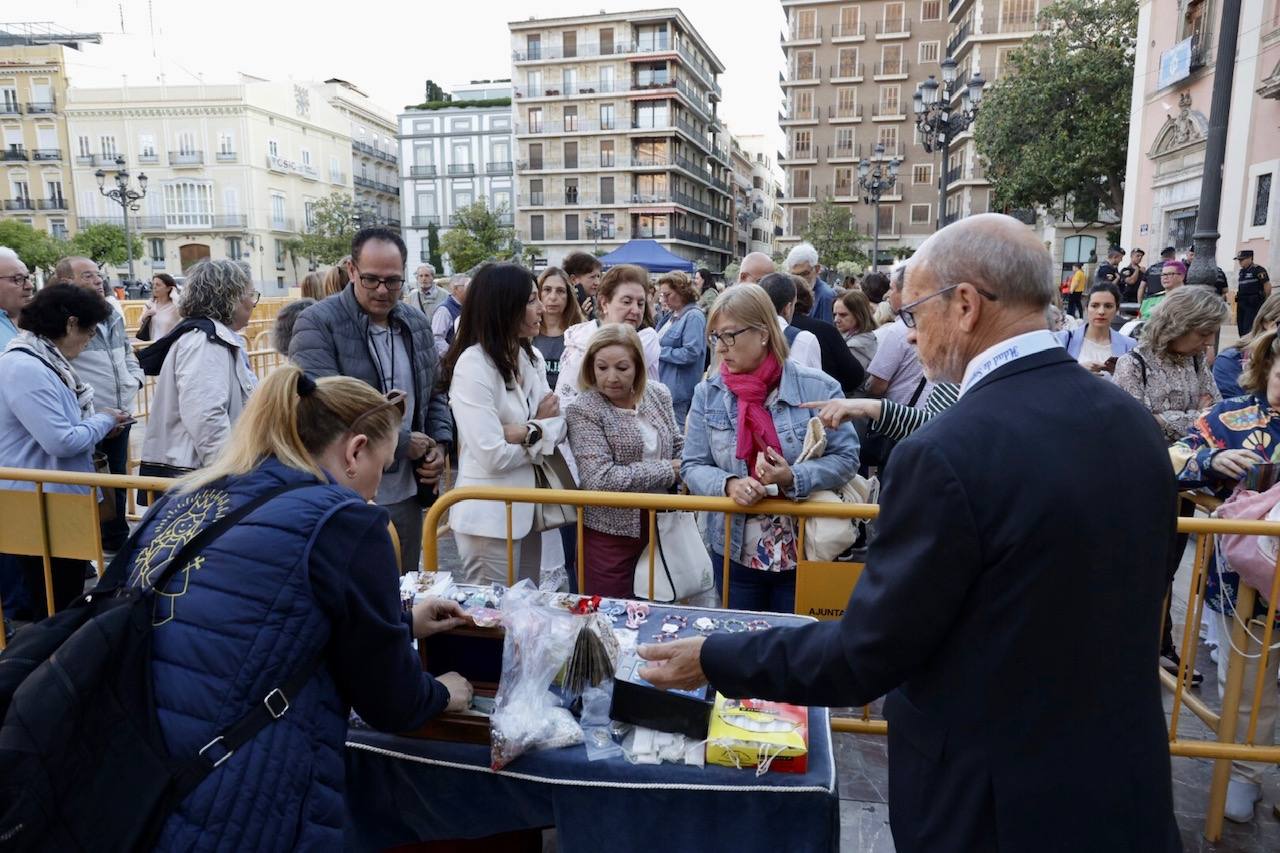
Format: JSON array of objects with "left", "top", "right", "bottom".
[{"left": 0, "top": 284, "right": 129, "bottom": 617}]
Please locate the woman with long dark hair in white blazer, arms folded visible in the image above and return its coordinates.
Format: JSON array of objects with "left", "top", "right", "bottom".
[{"left": 444, "top": 264, "right": 566, "bottom": 584}]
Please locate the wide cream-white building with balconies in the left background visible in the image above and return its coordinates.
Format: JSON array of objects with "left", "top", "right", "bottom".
[{"left": 67, "top": 78, "right": 352, "bottom": 295}]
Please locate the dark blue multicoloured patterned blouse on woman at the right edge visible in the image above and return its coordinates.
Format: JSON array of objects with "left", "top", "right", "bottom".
[{"left": 1169, "top": 394, "right": 1280, "bottom": 615}]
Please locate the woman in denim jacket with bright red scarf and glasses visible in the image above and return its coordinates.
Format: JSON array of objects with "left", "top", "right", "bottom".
[{"left": 680, "top": 284, "right": 858, "bottom": 612}]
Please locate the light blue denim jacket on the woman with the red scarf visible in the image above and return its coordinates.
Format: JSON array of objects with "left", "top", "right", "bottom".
[{"left": 680, "top": 361, "right": 858, "bottom": 564}]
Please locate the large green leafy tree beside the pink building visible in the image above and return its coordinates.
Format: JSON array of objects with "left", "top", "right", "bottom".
[{"left": 974, "top": 0, "right": 1138, "bottom": 227}]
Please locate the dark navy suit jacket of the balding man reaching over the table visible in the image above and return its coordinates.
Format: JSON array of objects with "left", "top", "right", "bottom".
[{"left": 701, "top": 350, "right": 1181, "bottom": 853}]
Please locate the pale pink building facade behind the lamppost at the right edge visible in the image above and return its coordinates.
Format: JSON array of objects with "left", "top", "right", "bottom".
[{"left": 1120, "top": 0, "right": 1280, "bottom": 272}]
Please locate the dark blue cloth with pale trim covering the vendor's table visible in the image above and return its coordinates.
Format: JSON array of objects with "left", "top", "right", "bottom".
[{"left": 347, "top": 607, "right": 840, "bottom": 853}]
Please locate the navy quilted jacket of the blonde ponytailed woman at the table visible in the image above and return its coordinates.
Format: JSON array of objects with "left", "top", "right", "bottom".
[{"left": 131, "top": 459, "right": 448, "bottom": 850}]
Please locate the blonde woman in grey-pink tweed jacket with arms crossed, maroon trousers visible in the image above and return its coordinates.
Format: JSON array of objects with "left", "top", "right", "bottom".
[{"left": 564, "top": 324, "right": 685, "bottom": 598}]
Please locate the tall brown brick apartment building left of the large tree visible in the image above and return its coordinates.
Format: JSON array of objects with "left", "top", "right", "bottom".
[{"left": 778, "top": 0, "right": 947, "bottom": 263}]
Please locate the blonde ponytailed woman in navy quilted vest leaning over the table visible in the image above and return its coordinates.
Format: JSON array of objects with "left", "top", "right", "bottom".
[{"left": 119, "top": 366, "right": 471, "bottom": 850}]
